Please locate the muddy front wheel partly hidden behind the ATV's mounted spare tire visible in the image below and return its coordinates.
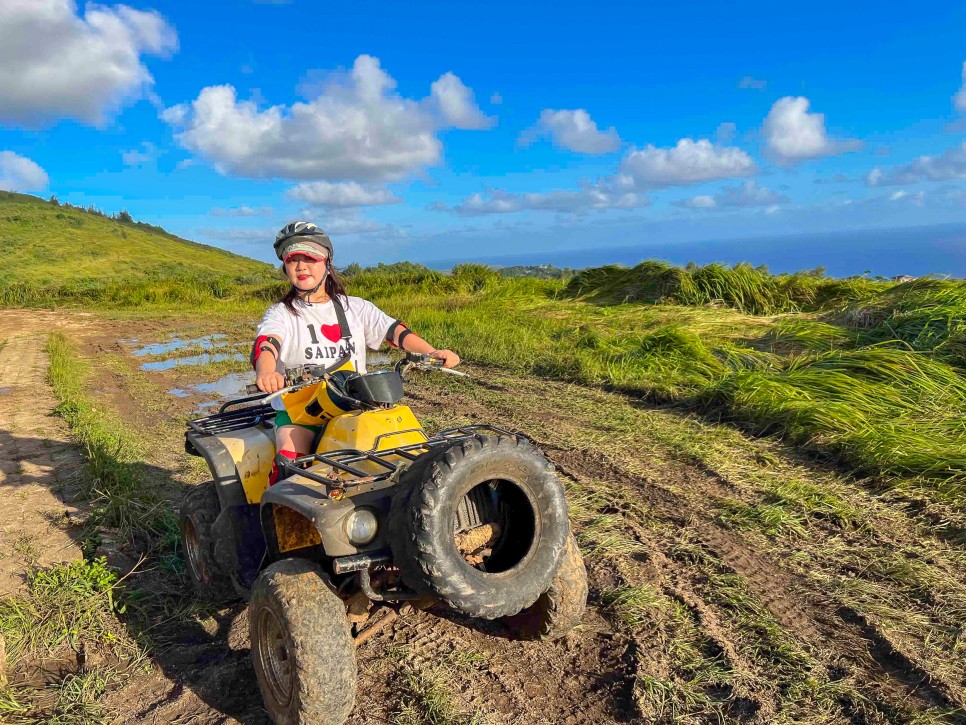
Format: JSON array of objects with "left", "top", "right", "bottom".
[{"left": 504, "top": 534, "right": 587, "bottom": 641}]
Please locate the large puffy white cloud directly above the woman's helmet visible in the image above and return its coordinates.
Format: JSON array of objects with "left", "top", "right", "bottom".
[{"left": 163, "top": 55, "right": 492, "bottom": 181}]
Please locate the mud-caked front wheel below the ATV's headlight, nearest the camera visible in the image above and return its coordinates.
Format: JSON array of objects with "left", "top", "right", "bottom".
[{"left": 248, "top": 559, "right": 356, "bottom": 725}]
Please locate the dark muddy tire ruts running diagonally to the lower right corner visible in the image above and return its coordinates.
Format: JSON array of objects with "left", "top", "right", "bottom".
[{"left": 410, "top": 381, "right": 962, "bottom": 720}]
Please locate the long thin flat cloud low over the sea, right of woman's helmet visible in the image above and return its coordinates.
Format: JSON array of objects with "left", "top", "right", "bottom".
[{"left": 429, "top": 184, "right": 650, "bottom": 216}]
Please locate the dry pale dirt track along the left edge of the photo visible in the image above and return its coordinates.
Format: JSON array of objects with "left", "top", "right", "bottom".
[{"left": 0, "top": 311, "right": 91, "bottom": 596}]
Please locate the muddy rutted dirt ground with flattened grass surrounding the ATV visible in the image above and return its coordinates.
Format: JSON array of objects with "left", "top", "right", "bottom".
[{"left": 0, "top": 312, "right": 966, "bottom": 725}]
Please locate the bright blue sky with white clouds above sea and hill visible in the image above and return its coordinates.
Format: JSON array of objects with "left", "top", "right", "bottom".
[{"left": 0, "top": 0, "right": 966, "bottom": 271}]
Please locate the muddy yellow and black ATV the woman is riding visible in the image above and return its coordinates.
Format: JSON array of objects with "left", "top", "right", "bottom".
[{"left": 180, "top": 353, "right": 587, "bottom": 725}]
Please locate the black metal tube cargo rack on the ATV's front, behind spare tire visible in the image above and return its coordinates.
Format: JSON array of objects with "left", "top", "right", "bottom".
[{"left": 280, "top": 425, "right": 522, "bottom": 488}]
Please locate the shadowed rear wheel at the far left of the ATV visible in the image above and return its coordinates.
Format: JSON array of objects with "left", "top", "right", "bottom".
[{"left": 178, "top": 481, "right": 238, "bottom": 604}]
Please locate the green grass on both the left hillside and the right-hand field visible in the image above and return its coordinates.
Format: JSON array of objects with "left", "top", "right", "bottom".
[{"left": 7, "top": 195, "right": 966, "bottom": 498}]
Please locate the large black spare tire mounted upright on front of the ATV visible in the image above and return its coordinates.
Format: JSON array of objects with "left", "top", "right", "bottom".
[{"left": 389, "top": 435, "right": 570, "bottom": 619}]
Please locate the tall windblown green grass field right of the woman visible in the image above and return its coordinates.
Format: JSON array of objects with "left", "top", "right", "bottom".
[{"left": 352, "top": 263, "right": 966, "bottom": 504}]
